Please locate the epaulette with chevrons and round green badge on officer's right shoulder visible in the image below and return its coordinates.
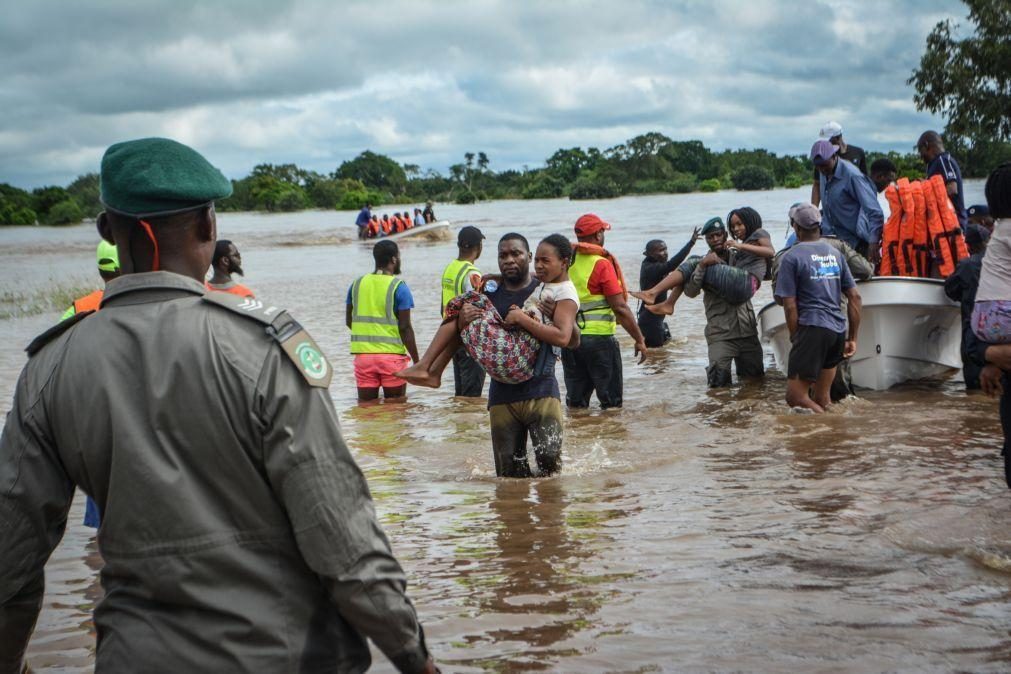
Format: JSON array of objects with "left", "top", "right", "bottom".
[{"left": 203, "top": 292, "right": 334, "bottom": 388}]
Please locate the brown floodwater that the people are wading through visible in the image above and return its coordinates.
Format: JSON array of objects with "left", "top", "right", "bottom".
[{"left": 0, "top": 183, "right": 1011, "bottom": 672}]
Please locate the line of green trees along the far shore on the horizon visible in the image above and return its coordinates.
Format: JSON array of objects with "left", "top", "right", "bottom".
[{"left": 0, "top": 132, "right": 1011, "bottom": 225}]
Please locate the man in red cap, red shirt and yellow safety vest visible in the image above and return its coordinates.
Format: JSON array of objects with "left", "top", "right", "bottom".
[{"left": 562, "top": 213, "right": 647, "bottom": 409}]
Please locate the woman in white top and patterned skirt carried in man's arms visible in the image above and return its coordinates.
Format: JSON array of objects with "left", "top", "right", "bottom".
[{"left": 395, "top": 234, "right": 579, "bottom": 388}]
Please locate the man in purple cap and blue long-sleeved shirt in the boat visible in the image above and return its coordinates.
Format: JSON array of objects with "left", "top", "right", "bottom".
[{"left": 811, "top": 140, "right": 885, "bottom": 264}]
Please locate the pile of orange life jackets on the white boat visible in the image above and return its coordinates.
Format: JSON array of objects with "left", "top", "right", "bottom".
[{"left": 879, "top": 175, "right": 969, "bottom": 278}]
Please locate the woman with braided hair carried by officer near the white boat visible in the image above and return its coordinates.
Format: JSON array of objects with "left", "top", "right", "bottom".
[{"left": 631, "top": 207, "right": 775, "bottom": 315}]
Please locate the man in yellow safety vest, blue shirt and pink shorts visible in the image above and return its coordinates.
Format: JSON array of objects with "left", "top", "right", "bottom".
[{"left": 347, "top": 240, "right": 418, "bottom": 402}]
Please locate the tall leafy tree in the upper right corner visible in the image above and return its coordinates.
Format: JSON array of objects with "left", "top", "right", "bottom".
[{"left": 907, "top": 0, "right": 1011, "bottom": 145}]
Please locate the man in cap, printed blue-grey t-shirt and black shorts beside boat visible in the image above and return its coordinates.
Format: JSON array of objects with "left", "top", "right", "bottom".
[{"left": 774, "top": 204, "right": 860, "bottom": 412}]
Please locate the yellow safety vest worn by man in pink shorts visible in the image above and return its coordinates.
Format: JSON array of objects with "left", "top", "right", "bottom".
[{"left": 351, "top": 274, "right": 407, "bottom": 354}]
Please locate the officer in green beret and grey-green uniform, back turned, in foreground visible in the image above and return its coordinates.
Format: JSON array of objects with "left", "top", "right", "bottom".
[{"left": 0, "top": 138, "right": 436, "bottom": 673}]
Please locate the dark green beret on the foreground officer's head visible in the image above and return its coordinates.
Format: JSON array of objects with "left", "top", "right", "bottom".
[{"left": 101, "top": 138, "right": 232, "bottom": 217}]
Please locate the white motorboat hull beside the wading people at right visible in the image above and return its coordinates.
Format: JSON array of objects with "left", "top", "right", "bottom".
[{"left": 758, "top": 276, "right": 961, "bottom": 391}]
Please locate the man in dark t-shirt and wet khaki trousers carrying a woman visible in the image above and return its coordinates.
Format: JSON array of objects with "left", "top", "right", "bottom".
[{"left": 460, "top": 233, "right": 578, "bottom": 477}]
